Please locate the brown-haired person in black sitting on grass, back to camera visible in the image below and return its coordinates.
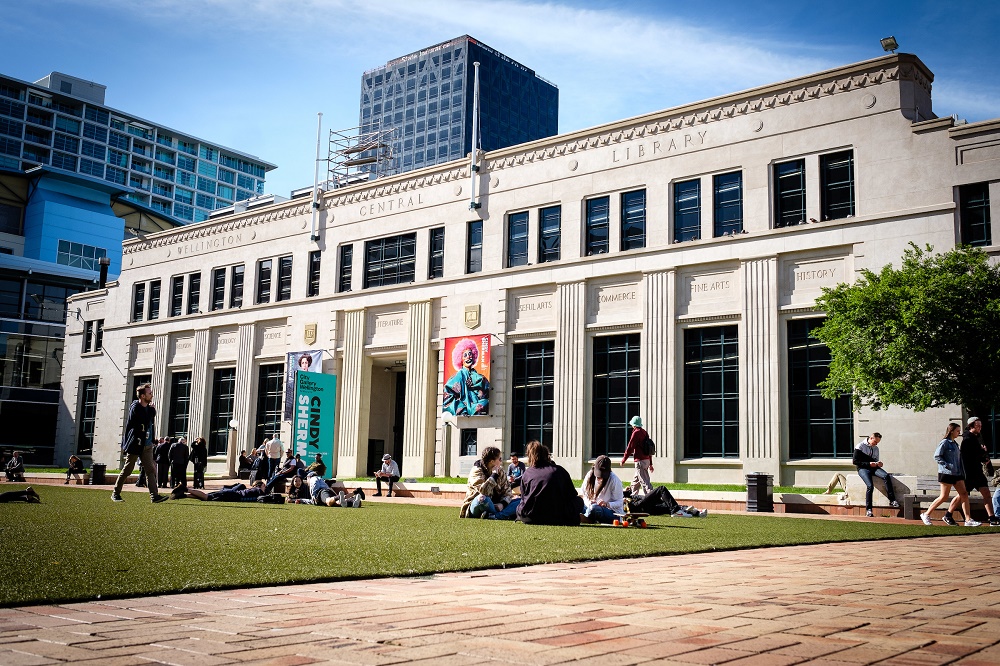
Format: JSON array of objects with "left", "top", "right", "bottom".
[{"left": 517, "top": 440, "right": 583, "bottom": 525}]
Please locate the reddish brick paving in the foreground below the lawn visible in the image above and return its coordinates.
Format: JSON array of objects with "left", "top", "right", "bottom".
[{"left": 0, "top": 528, "right": 1000, "bottom": 666}]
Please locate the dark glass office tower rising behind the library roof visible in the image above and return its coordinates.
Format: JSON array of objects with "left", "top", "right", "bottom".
[{"left": 360, "top": 35, "right": 559, "bottom": 173}]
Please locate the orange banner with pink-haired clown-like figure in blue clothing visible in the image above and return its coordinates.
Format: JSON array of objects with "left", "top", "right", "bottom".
[{"left": 442, "top": 334, "right": 492, "bottom": 416}]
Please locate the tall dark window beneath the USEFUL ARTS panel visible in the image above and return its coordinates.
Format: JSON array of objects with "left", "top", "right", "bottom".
[{"left": 510, "top": 340, "right": 556, "bottom": 454}]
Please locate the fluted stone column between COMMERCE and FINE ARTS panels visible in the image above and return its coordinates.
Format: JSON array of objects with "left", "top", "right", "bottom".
[{"left": 639, "top": 270, "right": 676, "bottom": 482}]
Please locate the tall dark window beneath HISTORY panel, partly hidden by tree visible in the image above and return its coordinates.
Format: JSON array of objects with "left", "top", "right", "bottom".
[{"left": 788, "top": 318, "right": 854, "bottom": 458}]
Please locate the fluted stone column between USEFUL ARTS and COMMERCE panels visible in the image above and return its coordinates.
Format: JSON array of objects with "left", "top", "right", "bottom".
[{"left": 552, "top": 282, "right": 591, "bottom": 479}]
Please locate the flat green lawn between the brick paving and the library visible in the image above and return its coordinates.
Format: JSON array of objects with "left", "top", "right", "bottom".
[{"left": 0, "top": 484, "right": 968, "bottom": 606}]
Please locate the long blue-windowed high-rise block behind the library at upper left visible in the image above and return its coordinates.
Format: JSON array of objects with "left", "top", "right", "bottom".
[{"left": 0, "top": 72, "right": 276, "bottom": 222}]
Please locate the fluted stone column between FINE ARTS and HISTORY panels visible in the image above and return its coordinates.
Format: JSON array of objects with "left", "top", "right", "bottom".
[{"left": 739, "top": 257, "right": 781, "bottom": 478}]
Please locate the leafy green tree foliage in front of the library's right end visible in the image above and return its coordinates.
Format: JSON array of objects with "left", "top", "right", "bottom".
[{"left": 813, "top": 243, "right": 1000, "bottom": 414}]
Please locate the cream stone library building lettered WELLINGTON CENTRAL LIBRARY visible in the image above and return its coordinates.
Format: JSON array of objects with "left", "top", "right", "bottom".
[{"left": 58, "top": 54, "right": 1000, "bottom": 485}]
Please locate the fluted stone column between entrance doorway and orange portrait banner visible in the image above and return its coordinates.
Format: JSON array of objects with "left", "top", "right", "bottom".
[{"left": 403, "top": 301, "right": 437, "bottom": 476}]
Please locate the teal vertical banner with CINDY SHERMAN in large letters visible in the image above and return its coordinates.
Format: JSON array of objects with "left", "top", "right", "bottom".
[{"left": 292, "top": 370, "right": 337, "bottom": 468}]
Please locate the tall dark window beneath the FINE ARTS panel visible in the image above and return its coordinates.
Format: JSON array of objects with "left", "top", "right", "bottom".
[{"left": 684, "top": 326, "right": 740, "bottom": 458}]
